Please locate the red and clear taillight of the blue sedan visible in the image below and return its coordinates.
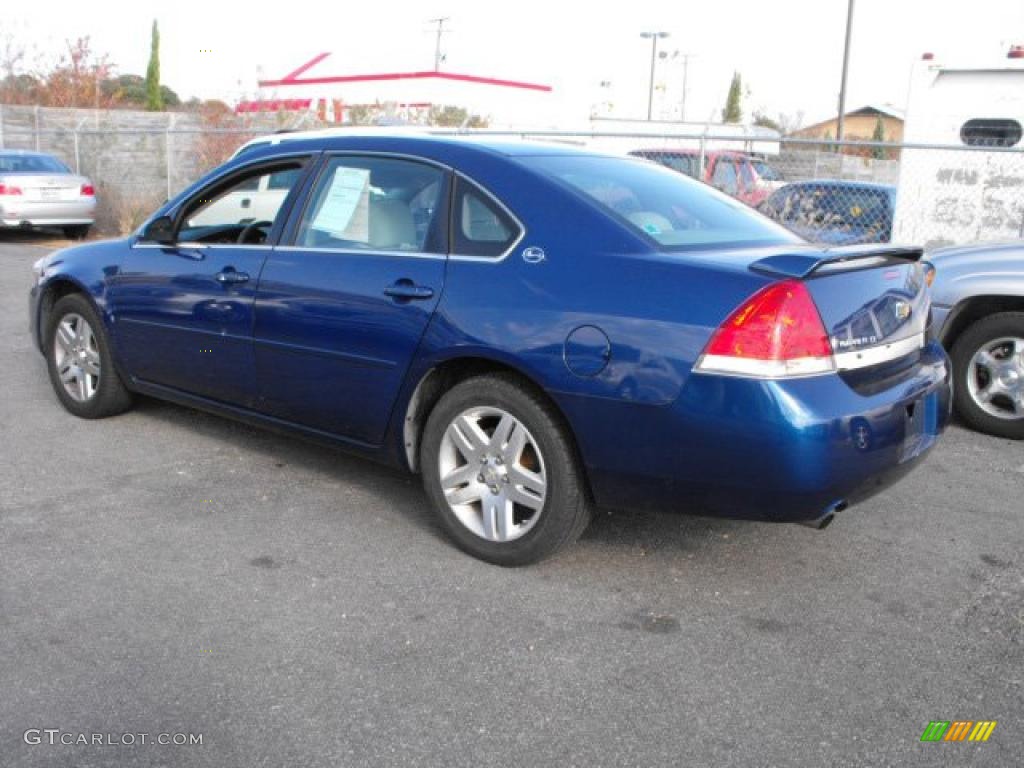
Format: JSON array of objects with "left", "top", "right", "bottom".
[{"left": 697, "top": 280, "right": 836, "bottom": 378}]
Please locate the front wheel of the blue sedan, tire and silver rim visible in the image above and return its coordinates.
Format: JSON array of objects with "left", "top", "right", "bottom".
[{"left": 44, "top": 294, "right": 131, "bottom": 419}]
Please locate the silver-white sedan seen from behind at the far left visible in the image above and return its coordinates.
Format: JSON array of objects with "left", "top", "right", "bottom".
[{"left": 0, "top": 150, "right": 96, "bottom": 239}]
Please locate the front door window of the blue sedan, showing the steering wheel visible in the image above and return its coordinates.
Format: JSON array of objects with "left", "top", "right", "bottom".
[{"left": 177, "top": 161, "right": 303, "bottom": 244}]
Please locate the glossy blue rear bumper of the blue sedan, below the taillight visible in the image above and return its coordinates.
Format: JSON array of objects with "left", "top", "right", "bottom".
[{"left": 563, "top": 342, "right": 950, "bottom": 522}]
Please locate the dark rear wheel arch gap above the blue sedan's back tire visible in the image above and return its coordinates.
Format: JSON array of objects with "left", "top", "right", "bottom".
[{"left": 401, "top": 356, "right": 593, "bottom": 499}]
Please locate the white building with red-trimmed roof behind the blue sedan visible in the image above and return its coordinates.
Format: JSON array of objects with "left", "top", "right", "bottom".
[{"left": 236, "top": 53, "right": 552, "bottom": 125}]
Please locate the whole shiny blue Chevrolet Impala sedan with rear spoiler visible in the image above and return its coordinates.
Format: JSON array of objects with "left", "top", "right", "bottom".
[{"left": 30, "top": 136, "right": 950, "bottom": 565}]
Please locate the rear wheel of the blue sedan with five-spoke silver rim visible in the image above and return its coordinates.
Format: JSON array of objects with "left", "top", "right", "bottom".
[{"left": 420, "top": 374, "right": 591, "bottom": 566}]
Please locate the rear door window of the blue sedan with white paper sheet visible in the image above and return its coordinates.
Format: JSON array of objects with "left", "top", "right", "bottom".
[{"left": 295, "top": 157, "right": 445, "bottom": 253}]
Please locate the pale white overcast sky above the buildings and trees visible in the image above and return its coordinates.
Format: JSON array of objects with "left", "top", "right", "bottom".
[{"left": 0, "top": 0, "right": 1024, "bottom": 125}]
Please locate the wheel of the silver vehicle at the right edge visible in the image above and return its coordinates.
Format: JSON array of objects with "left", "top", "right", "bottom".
[{"left": 950, "top": 312, "right": 1024, "bottom": 440}]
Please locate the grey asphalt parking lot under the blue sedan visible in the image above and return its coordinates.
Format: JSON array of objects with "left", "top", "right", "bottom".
[{"left": 0, "top": 237, "right": 1024, "bottom": 768}]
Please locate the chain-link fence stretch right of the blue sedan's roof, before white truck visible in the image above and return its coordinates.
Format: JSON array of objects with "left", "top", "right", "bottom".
[{"left": 499, "top": 132, "right": 1024, "bottom": 248}]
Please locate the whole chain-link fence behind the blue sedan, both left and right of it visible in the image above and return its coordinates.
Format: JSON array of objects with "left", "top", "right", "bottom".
[{"left": 0, "top": 120, "right": 1024, "bottom": 247}]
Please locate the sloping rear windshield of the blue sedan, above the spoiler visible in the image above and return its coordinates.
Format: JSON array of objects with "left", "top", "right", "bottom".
[{"left": 522, "top": 156, "right": 801, "bottom": 251}]
